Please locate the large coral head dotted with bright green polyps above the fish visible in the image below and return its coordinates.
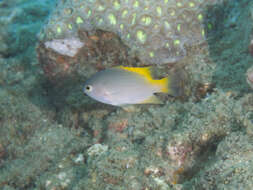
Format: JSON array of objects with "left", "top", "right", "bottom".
[{"left": 38, "top": 0, "right": 219, "bottom": 64}]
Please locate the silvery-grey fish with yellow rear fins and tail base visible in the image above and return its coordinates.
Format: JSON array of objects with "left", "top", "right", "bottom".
[{"left": 84, "top": 67, "right": 170, "bottom": 106}]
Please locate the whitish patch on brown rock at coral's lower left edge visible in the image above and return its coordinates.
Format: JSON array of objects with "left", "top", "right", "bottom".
[{"left": 45, "top": 38, "right": 84, "bottom": 57}]
